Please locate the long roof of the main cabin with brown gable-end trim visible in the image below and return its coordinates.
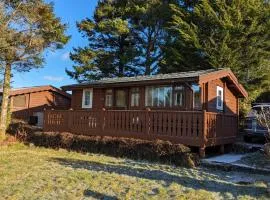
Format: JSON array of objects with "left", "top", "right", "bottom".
[{"left": 62, "top": 69, "right": 247, "bottom": 97}]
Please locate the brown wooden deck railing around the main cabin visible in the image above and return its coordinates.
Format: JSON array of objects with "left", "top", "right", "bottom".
[{"left": 44, "top": 110, "right": 237, "bottom": 147}]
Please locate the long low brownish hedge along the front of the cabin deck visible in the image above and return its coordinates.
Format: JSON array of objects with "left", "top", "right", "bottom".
[{"left": 10, "top": 122, "right": 199, "bottom": 167}]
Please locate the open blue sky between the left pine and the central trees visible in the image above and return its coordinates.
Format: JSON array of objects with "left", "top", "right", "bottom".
[{"left": 12, "top": 0, "right": 98, "bottom": 88}]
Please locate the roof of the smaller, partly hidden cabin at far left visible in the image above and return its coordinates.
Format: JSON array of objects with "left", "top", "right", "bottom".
[{"left": 0, "top": 85, "right": 71, "bottom": 98}]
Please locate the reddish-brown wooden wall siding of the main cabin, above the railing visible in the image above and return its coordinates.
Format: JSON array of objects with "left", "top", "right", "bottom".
[{"left": 71, "top": 78, "right": 239, "bottom": 114}]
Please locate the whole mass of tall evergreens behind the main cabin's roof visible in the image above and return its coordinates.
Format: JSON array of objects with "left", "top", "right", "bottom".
[{"left": 67, "top": 0, "right": 270, "bottom": 111}]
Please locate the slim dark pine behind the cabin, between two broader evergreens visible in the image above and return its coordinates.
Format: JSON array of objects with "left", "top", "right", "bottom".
[{"left": 126, "top": 0, "right": 177, "bottom": 75}]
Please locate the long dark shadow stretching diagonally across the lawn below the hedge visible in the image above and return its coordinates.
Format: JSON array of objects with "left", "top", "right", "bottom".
[{"left": 51, "top": 158, "right": 266, "bottom": 198}]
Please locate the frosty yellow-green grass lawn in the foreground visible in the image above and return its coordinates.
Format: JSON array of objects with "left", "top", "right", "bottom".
[{"left": 0, "top": 144, "right": 270, "bottom": 200}]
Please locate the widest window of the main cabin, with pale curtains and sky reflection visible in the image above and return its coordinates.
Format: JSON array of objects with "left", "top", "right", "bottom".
[{"left": 145, "top": 86, "right": 172, "bottom": 107}]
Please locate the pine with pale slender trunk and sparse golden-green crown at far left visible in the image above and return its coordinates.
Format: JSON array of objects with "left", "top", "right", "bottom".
[{"left": 0, "top": 0, "right": 69, "bottom": 139}]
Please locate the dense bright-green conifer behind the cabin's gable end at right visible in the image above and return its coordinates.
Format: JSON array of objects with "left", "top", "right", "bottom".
[{"left": 171, "top": 0, "right": 270, "bottom": 112}]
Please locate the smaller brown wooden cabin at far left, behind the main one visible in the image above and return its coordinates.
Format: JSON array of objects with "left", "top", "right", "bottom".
[{"left": 0, "top": 85, "right": 71, "bottom": 126}]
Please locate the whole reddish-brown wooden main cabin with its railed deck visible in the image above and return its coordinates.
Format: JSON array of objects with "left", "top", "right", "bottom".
[{"left": 45, "top": 69, "right": 247, "bottom": 154}]
